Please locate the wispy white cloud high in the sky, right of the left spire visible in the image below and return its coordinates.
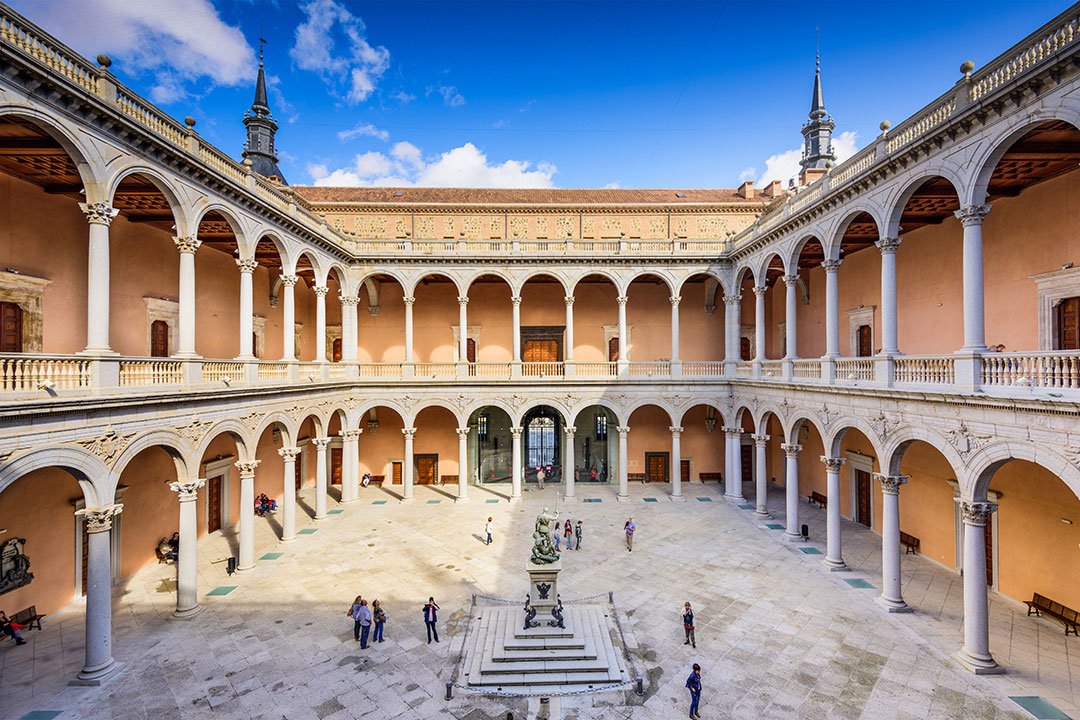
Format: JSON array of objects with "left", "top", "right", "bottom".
[{"left": 288, "top": 0, "right": 390, "bottom": 104}]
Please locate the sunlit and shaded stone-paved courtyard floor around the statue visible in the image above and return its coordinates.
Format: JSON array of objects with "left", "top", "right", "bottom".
[{"left": 0, "top": 484, "right": 1080, "bottom": 720}]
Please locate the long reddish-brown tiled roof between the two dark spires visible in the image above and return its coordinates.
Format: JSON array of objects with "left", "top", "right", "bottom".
[{"left": 292, "top": 186, "right": 772, "bottom": 206}]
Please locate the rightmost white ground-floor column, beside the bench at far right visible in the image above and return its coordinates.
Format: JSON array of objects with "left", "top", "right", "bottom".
[{"left": 956, "top": 498, "right": 1002, "bottom": 675}]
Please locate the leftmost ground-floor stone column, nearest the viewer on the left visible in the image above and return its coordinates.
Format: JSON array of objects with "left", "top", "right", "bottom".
[{"left": 76, "top": 504, "right": 123, "bottom": 685}]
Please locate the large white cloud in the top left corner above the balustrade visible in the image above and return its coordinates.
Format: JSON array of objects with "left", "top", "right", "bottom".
[{"left": 12, "top": 0, "right": 256, "bottom": 103}]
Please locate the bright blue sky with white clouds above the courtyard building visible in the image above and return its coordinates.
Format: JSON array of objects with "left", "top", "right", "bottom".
[{"left": 11, "top": 0, "right": 1069, "bottom": 188}]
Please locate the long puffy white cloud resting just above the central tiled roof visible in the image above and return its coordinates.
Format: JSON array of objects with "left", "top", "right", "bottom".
[{"left": 308, "top": 142, "right": 558, "bottom": 188}]
